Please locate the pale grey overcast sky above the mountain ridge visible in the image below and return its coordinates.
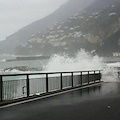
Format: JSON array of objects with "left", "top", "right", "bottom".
[{"left": 0, "top": 0, "right": 68, "bottom": 40}]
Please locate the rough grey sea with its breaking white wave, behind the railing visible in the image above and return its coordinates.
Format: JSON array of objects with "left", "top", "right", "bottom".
[{"left": 0, "top": 49, "right": 120, "bottom": 79}]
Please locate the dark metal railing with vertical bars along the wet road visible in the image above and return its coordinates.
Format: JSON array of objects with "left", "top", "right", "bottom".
[{"left": 0, "top": 70, "right": 101, "bottom": 101}]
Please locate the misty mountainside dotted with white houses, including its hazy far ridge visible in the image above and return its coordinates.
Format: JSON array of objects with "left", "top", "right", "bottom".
[{"left": 0, "top": 0, "right": 120, "bottom": 56}]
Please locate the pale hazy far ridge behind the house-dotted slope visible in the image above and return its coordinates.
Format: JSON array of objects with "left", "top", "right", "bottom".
[{"left": 0, "top": 0, "right": 94, "bottom": 54}]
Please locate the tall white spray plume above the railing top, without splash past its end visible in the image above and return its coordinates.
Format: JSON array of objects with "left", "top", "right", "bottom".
[{"left": 44, "top": 50, "right": 103, "bottom": 72}]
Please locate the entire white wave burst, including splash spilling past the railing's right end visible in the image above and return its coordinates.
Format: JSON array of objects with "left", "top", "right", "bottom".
[{"left": 44, "top": 49, "right": 118, "bottom": 82}]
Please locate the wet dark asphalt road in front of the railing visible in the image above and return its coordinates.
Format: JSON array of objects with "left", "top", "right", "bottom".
[{"left": 0, "top": 82, "right": 120, "bottom": 120}]
